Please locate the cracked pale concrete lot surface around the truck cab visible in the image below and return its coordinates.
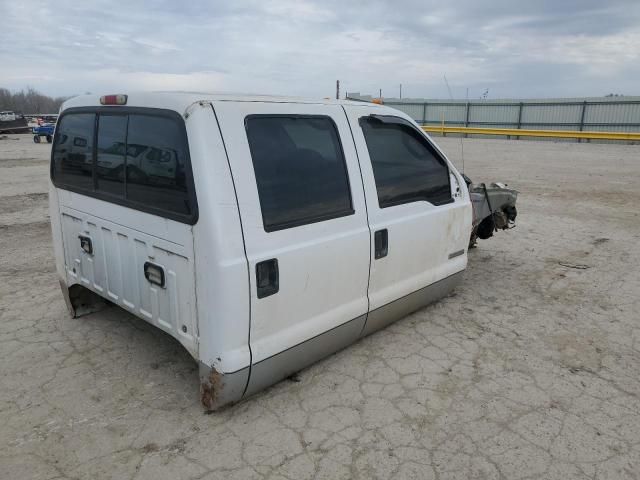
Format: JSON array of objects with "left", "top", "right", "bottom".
[{"left": 0, "top": 136, "right": 640, "bottom": 480}]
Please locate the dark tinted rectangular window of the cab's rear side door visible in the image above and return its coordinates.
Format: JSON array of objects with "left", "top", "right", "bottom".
[{"left": 246, "top": 115, "right": 353, "bottom": 231}]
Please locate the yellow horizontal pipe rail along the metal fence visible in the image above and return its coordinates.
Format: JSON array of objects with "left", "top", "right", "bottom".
[{"left": 422, "top": 125, "right": 640, "bottom": 141}]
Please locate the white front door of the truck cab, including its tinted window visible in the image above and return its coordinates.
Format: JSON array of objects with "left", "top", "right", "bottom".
[{"left": 345, "top": 106, "right": 471, "bottom": 334}]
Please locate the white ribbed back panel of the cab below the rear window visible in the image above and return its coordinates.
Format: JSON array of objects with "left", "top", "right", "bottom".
[{"left": 59, "top": 195, "right": 198, "bottom": 355}]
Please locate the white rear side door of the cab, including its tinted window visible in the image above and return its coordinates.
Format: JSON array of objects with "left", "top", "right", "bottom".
[{"left": 214, "top": 102, "right": 370, "bottom": 394}]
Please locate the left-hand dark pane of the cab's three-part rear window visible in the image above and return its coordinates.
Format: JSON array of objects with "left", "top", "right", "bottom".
[{"left": 53, "top": 113, "right": 96, "bottom": 190}]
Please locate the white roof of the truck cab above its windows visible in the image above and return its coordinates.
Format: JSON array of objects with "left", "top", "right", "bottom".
[{"left": 60, "top": 92, "right": 382, "bottom": 113}]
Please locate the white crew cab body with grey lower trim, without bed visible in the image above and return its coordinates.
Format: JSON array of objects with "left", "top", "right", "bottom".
[{"left": 49, "top": 93, "right": 472, "bottom": 409}]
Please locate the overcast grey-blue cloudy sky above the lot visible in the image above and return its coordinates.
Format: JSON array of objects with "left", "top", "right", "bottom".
[{"left": 0, "top": 0, "right": 640, "bottom": 98}]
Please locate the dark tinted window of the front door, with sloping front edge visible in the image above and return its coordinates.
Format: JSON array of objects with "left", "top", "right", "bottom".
[{"left": 360, "top": 117, "right": 452, "bottom": 208}]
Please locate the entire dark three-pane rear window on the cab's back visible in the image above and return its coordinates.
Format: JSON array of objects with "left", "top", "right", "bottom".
[{"left": 51, "top": 108, "right": 197, "bottom": 224}]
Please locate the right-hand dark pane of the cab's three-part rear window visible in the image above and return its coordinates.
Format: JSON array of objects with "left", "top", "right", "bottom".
[{"left": 127, "top": 115, "right": 191, "bottom": 214}]
